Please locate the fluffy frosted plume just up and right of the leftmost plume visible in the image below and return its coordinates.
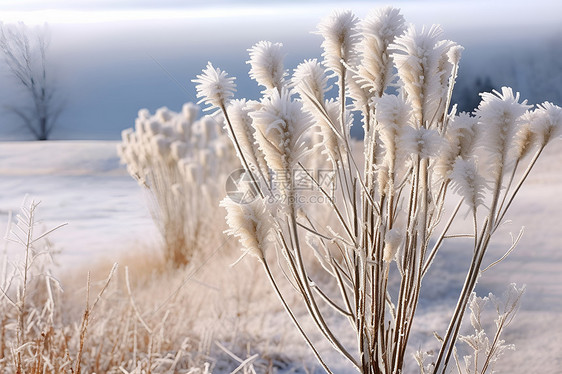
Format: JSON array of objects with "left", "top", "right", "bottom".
[{"left": 246, "top": 41, "right": 286, "bottom": 92}]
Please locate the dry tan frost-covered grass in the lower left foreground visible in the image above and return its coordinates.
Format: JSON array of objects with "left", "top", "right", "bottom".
[{"left": 0, "top": 203, "right": 312, "bottom": 374}]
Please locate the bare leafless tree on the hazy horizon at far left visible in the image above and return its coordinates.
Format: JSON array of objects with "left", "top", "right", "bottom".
[{"left": 0, "top": 22, "right": 62, "bottom": 140}]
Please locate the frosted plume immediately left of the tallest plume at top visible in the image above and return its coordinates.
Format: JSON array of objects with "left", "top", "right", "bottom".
[{"left": 317, "top": 11, "right": 359, "bottom": 76}]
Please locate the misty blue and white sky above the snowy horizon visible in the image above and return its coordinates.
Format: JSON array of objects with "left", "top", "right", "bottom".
[{"left": 0, "top": 0, "right": 562, "bottom": 139}]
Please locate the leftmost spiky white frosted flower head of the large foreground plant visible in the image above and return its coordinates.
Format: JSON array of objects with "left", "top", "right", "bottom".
[{"left": 193, "top": 62, "right": 236, "bottom": 110}]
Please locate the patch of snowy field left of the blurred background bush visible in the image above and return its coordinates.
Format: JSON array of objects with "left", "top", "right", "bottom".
[{"left": 0, "top": 141, "right": 158, "bottom": 268}]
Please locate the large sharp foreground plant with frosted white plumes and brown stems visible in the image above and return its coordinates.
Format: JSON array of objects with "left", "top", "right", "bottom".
[{"left": 195, "top": 8, "right": 562, "bottom": 374}]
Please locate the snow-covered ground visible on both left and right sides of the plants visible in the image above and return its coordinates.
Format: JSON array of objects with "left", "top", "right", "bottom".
[{"left": 0, "top": 141, "right": 562, "bottom": 373}]
